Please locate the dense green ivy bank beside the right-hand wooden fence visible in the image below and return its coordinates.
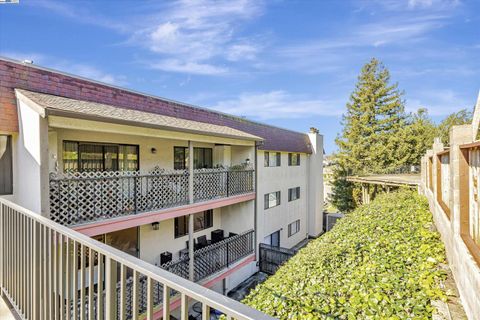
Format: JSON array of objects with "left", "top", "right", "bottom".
[{"left": 243, "top": 190, "right": 445, "bottom": 319}]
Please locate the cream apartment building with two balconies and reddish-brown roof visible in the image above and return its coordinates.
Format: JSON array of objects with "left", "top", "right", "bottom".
[{"left": 0, "top": 58, "right": 323, "bottom": 318}]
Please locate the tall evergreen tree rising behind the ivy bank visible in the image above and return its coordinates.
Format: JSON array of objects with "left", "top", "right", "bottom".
[{"left": 331, "top": 58, "right": 406, "bottom": 211}]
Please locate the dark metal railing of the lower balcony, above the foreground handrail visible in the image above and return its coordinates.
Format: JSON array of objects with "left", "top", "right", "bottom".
[{"left": 162, "top": 230, "right": 255, "bottom": 281}]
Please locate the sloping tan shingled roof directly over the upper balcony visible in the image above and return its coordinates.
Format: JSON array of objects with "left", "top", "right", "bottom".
[{"left": 17, "top": 89, "right": 262, "bottom": 140}]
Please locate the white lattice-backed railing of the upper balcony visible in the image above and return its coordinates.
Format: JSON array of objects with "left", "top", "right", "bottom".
[{"left": 49, "top": 168, "right": 255, "bottom": 226}]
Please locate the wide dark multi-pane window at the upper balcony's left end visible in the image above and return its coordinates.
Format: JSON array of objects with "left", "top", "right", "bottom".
[{"left": 63, "top": 141, "right": 139, "bottom": 172}]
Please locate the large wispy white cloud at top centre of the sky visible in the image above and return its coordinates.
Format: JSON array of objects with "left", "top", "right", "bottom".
[{"left": 129, "top": 0, "right": 262, "bottom": 75}]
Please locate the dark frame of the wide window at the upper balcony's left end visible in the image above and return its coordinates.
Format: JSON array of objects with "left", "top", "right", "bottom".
[{"left": 62, "top": 140, "right": 140, "bottom": 172}]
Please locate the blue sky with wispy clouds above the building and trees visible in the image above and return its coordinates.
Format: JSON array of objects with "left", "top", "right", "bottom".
[{"left": 0, "top": 0, "right": 480, "bottom": 153}]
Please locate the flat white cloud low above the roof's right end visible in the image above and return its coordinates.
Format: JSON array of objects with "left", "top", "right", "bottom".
[{"left": 212, "top": 90, "right": 344, "bottom": 120}]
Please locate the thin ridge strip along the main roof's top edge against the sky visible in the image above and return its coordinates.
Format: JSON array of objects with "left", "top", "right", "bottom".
[{"left": 0, "top": 55, "right": 306, "bottom": 135}]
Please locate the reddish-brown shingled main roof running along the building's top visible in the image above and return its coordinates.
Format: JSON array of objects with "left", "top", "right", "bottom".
[{"left": 0, "top": 58, "right": 311, "bottom": 153}]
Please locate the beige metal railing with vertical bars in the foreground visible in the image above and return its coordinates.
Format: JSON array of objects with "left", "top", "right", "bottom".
[{"left": 0, "top": 199, "right": 273, "bottom": 320}]
